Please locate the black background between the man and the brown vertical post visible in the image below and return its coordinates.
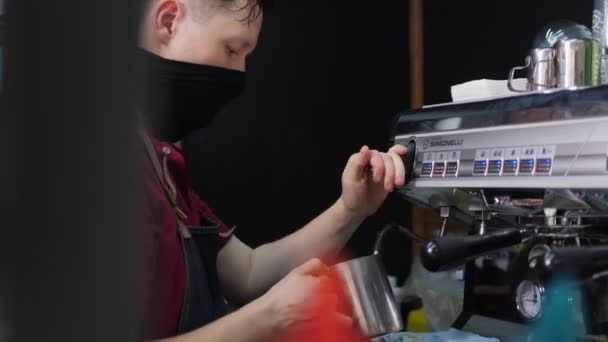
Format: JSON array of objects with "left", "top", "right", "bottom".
[{"left": 186, "top": 1, "right": 409, "bottom": 266}]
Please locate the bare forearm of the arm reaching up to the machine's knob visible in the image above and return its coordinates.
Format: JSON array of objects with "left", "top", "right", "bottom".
[{"left": 248, "top": 199, "right": 365, "bottom": 297}]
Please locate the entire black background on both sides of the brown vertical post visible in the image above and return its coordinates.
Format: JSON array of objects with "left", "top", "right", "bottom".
[{"left": 186, "top": 0, "right": 592, "bottom": 280}]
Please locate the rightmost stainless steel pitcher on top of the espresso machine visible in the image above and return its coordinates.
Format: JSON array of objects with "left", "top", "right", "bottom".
[{"left": 555, "top": 39, "right": 602, "bottom": 88}]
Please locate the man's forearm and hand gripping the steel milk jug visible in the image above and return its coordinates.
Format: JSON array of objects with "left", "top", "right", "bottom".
[{"left": 162, "top": 259, "right": 364, "bottom": 342}]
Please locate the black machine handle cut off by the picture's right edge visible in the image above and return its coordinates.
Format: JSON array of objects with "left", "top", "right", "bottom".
[{"left": 534, "top": 246, "right": 608, "bottom": 278}]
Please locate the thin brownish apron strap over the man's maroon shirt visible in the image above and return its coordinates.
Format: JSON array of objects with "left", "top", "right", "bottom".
[{"left": 138, "top": 128, "right": 192, "bottom": 239}]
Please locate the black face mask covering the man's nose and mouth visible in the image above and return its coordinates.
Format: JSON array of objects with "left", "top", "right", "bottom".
[{"left": 136, "top": 49, "right": 245, "bottom": 142}]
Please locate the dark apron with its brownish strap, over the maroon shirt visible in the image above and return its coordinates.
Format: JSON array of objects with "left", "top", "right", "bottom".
[{"left": 140, "top": 132, "right": 227, "bottom": 335}]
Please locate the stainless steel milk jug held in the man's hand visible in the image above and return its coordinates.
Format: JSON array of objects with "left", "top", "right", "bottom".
[{"left": 333, "top": 227, "right": 403, "bottom": 337}]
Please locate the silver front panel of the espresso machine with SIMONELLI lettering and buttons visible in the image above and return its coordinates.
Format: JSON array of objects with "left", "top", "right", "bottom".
[{"left": 396, "top": 116, "right": 608, "bottom": 190}]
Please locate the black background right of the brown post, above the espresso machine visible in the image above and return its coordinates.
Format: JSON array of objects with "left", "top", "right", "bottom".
[{"left": 424, "top": 0, "right": 593, "bottom": 104}]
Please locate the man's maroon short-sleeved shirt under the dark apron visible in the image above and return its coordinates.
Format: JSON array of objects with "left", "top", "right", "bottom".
[{"left": 142, "top": 137, "right": 231, "bottom": 339}]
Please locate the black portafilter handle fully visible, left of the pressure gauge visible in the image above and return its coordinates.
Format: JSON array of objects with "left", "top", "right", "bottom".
[{"left": 420, "top": 228, "right": 524, "bottom": 272}]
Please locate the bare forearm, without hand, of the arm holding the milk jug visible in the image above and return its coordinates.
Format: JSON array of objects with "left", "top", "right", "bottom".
[{"left": 157, "top": 300, "right": 279, "bottom": 342}]
